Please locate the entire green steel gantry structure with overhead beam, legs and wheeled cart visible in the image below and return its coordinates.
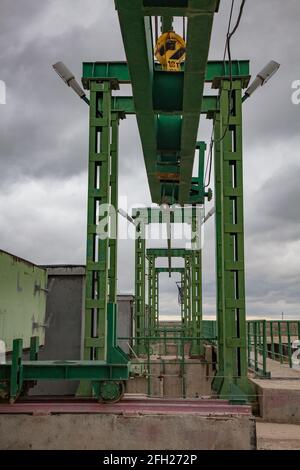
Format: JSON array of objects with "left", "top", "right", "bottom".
[{"left": 0, "top": 0, "right": 255, "bottom": 402}]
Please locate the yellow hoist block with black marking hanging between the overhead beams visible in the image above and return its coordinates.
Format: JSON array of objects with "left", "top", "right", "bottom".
[{"left": 155, "top": 31, "right": 186, "bottom": 72}]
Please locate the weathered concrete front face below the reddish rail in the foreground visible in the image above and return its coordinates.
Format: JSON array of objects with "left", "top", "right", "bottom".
[{"left": 0, "top": 412, "right": 256, "bottom": 450}]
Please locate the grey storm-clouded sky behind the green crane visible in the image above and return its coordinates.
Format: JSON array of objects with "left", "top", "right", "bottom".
[{"left": 0, "top": 0, "right": 300, "bottom": 318}]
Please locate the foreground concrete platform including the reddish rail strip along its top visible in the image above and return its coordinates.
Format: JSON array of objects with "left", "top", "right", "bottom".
[{"left": 0, "top": 399, "right": 256, "bottom": 450}]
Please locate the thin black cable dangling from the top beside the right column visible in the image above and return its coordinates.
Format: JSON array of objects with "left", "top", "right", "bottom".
[{"left": 204, "top": 0, "right": 246, "bottom": 188}]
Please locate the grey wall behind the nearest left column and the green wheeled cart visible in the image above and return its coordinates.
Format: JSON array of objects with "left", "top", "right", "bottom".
[{"left": 30, "top": 266, "right": 134, "bottom": 395}]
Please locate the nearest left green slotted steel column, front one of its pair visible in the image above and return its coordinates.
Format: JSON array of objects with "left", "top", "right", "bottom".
[{"left": 84, "top": 81, "right": 111, "bottom": 360}]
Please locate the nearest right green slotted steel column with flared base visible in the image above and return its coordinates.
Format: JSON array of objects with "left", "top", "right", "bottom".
[{"left": 213, "top": 80, "right": 251, "bottom": 401}]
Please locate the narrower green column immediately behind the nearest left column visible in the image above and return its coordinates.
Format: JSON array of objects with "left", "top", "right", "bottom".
[{"left": 108, "top": 113, "right": 119, "bottom": 303}]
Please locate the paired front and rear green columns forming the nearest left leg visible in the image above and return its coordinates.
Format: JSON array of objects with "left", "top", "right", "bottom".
[{"left": 77, "top": 80, "right": 119, "bottom": 396}]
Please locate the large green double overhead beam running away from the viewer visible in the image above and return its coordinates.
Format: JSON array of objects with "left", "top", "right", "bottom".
[{"left": 115, "top": 0, "right": 221, "bottom": 204}]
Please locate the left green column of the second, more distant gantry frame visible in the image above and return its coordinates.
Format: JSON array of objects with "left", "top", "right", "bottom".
[{"left": 135, "top": 223, "right": 146, "bottom": 355}]
